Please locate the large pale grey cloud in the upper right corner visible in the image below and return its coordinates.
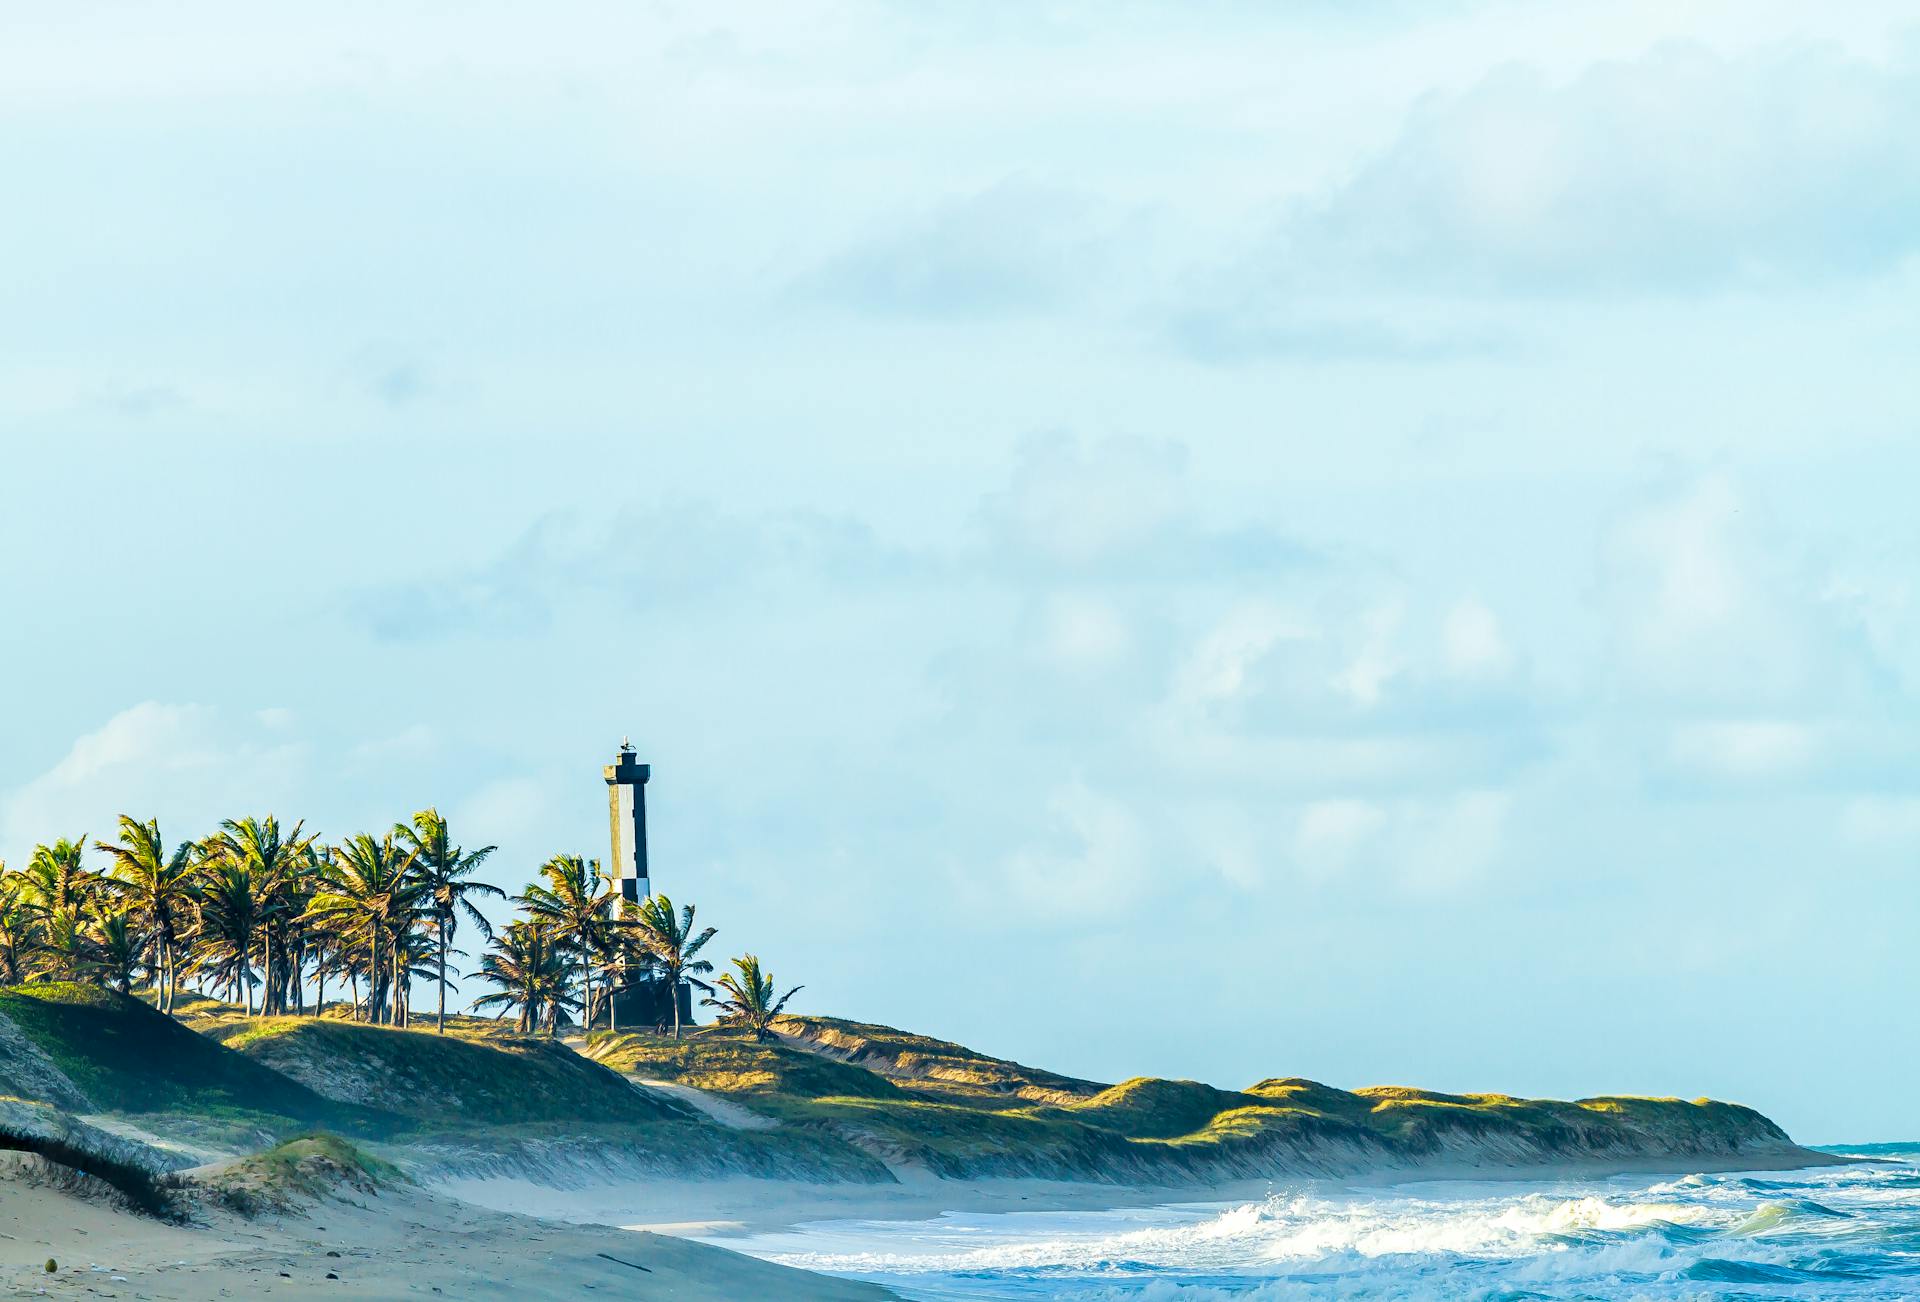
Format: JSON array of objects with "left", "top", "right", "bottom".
[{"left": 1261, "top": 44, "right": 1920, "bottom": 294}]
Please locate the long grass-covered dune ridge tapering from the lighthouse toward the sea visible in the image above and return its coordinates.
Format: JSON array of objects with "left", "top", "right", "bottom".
[{"left": 588, "top": 1018, "right": 1788, "bottom": 1183}]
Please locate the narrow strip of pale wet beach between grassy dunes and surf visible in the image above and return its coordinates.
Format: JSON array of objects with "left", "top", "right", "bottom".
[{"left": 426, "top": 1146, "right": 1859, "bottom": 1241}]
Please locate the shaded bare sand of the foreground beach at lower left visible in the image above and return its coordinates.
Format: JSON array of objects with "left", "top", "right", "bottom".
[{"left": 0, "top": 1179, "right": 895, "bottom": 1302}]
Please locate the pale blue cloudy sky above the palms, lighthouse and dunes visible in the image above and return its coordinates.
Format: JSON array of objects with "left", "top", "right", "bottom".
[{"left": 0, "top": 0, "right": 1920, "bottom": 1143}]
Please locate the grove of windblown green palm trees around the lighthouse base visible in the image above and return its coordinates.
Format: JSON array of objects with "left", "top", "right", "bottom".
[{"left": 0, "top": 808, "right": 781, "bottom": 1035}]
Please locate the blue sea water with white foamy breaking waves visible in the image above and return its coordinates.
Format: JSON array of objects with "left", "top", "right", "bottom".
[{"left": 728, "top": 1145, "right": 1920, "bottom": 1302}]
